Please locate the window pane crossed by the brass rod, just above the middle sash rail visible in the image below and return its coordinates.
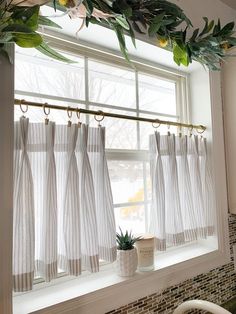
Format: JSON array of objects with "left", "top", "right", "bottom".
[{"left": 89, "top": 106, "right": 137, "bottom": 149}]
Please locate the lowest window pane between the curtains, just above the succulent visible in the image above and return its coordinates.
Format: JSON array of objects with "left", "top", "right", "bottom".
[{"left": 115, "top": 205, "right": 145, "bottom": 234}]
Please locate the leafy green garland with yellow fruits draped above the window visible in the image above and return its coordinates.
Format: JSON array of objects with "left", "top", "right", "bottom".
[{"left": 0, "top": 0, "right": 236, "bottom": 70}]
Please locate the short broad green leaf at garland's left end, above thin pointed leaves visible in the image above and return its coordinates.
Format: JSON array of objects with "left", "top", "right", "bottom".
[{"left": 12, "top": 33, "right": 43, "bottom": 48}]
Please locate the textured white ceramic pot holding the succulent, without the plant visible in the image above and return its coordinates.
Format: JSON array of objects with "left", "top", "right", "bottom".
[{"left": 116, "top": 248, "right": 138, "bottom": 277}]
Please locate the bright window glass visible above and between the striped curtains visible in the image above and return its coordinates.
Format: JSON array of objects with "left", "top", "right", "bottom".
[{"left": 15, "top": 45, "right": 186, "bottom": 237}]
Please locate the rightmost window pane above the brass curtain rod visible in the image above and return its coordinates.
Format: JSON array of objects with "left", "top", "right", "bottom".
[{"left": 138, "top": 74, "right": 176, "bottom": 115}]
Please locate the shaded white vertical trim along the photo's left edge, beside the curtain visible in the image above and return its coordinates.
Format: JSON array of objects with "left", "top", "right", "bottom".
[{"left": 0, "top": 45, "right": 14, "bottom": 314}]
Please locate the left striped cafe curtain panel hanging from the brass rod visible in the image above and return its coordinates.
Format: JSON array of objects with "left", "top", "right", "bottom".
[{"left": 13, "top": 118, "right": 116, "bottom": 292}]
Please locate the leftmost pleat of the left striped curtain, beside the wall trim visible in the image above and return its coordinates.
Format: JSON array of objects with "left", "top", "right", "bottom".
[{"left": 13, "top": 117, "right": 35, "bottom": 291}]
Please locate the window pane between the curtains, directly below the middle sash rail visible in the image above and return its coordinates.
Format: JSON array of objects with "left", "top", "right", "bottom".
[{"left": 108, "top": 160, "right": 144, "bottom": 204}]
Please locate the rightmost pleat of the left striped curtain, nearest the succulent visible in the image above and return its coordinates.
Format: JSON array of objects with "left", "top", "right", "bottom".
[{"left": 88, "top": 127, "right": 116, "bottom": 262}]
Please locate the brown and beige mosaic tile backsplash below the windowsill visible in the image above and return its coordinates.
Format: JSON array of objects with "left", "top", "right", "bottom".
[{"left": 106, "top": 214, "right": 236, "bottom": 314}]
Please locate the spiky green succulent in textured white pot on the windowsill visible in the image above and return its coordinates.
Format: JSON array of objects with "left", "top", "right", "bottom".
[{"left": 116, "top": 228, "right": 139, "bottom": 277}]
